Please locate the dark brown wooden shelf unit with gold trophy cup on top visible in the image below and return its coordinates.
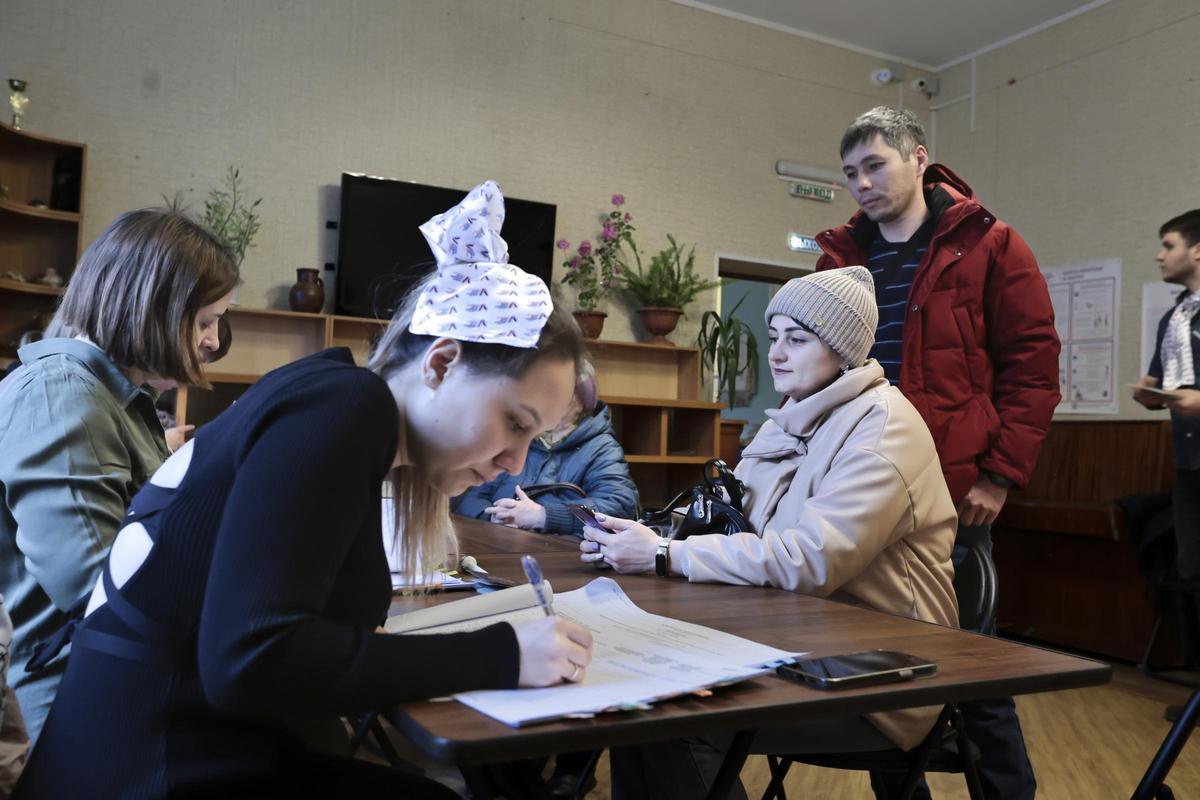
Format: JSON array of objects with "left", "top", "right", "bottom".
[{"left": 0, "top": 122, "right": 88, "bottom": 366}]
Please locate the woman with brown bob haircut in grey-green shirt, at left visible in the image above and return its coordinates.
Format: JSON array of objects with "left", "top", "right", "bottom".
[{"left": 0, "top": 210, "right": 238, "bottom": 740}]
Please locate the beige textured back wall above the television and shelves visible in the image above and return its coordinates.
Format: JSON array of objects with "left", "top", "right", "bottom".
[{"left": 0, "top": 0, "right": 926, "bottom": 343}]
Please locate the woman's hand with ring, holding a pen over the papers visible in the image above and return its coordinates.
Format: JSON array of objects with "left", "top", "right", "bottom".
[{"left": 512, "top": 555, "right": 592, "bottom": 686}]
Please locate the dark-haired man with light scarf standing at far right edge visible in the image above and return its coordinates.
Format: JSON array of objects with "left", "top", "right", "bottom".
[{"left": 1133, "top": 209, "right": 1200, "bottom": 581}]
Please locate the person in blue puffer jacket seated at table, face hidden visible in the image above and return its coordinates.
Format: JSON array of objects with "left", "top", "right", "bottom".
[{"left": 450, "top": 362, "right": 637, "bottom": 539}]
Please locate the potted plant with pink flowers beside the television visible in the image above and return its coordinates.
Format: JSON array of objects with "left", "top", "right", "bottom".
[{"left": 556, "top": 194, "right": 636, "bottom": 339}]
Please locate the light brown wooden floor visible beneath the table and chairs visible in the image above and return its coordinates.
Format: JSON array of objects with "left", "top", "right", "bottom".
[{"left": 588, "top": 666, "right": 1200, "bottom": 800}]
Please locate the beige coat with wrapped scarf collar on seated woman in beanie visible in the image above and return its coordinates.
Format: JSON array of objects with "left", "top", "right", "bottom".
[{"left": 671, "top": 360, "right": 958, "bottom": 750}]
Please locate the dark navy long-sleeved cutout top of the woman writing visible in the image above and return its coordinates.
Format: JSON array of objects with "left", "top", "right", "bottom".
[{"left": 18, "top": 349, "right": 518, "bottom": 798}]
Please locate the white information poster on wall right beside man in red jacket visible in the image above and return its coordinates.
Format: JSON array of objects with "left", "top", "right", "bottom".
[{"left": 1042, "top": 259, "right": 1121, "bottom": 414}]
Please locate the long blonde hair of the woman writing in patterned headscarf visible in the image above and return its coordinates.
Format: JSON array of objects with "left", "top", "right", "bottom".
[{"left": 367, "top": 275, "right": 586, "bottom": 582}]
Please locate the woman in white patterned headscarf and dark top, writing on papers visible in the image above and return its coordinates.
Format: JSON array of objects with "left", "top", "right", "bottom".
[{"left": 17, "top": 181, "right": 592, "bottom": 798}]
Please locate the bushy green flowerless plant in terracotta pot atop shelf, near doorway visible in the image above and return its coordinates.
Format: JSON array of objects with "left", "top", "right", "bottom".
[{"left": 620, "top": 234, "right": 721, "bottom": 344}]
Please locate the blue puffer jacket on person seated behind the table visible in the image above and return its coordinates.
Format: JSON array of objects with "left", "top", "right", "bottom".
[{"left": 450, "top": 403, "right": 637, "bottom": 539}]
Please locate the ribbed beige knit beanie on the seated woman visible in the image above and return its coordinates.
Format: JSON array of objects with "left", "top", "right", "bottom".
[{"left": 763, "top": 266, "right": 880, "bottom": 368}]
